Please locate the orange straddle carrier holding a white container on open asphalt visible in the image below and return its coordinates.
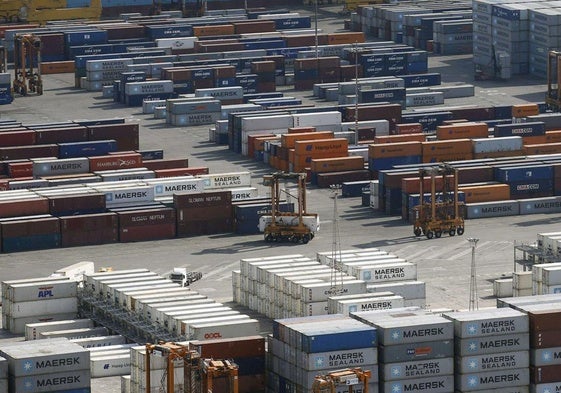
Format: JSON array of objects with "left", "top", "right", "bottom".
[{"left": 263, "top": 171, "right": 315, "bottom": 244}]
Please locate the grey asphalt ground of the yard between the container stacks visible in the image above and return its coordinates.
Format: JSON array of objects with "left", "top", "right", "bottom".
[{"left": 0, "top": 6, "right": 561, "bottom": 393}]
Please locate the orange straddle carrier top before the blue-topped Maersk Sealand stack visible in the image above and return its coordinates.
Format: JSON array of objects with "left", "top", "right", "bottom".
[{"left": 312, "top": 368, "right": 371, "bottom": 393}]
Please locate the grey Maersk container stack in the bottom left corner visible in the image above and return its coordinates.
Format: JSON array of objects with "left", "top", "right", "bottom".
[{"left": 0, "top": 339, "right": 91, "bottom": 393}]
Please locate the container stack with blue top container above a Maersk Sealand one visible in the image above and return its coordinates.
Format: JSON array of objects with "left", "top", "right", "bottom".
[{"left": 267, "top": 314, "right": 378, "bottom": 392}]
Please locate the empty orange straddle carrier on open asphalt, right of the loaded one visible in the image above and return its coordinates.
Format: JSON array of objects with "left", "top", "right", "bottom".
[{"left": 413, "top": 164, "right": 464, "bottom": 239}]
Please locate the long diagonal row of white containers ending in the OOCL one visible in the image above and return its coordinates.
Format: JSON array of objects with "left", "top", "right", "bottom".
[{"left": 82, "top": 269, "right": 258, "bottom": 340}]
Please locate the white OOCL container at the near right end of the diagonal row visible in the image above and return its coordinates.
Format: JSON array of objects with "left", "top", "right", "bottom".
[{"left": 188, "top": 319, "right": 259, "bottom": 340}]
